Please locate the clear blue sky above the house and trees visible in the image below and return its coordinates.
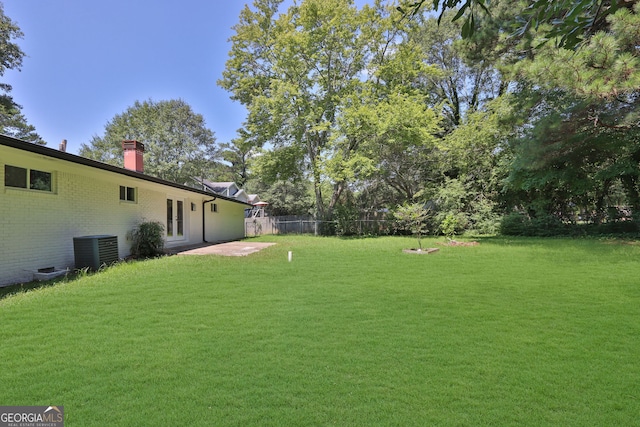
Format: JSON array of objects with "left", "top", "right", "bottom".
[{"left": 0, "top": 0, "right": 366, "bottom": 154}]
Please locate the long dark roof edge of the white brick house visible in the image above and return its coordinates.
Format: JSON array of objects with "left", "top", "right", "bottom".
[{"left": 0, "top": 134, "right": 248, "bottom": 205}]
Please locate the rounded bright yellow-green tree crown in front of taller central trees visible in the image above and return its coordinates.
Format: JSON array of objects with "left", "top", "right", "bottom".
[{"left": 338, "top": 90, "right": 440, "bottom": 204}]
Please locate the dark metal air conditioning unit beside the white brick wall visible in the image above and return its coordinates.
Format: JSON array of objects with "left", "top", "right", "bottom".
[{"left": 73, "top": 235, "right": 118, "bottom": 271}]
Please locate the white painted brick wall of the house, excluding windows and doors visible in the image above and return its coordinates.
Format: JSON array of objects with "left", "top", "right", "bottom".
[{"left": 0, "top": 146, "right": 245, "bottom": 285}]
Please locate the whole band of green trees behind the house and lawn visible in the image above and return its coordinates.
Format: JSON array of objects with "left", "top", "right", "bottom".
[{"left": 0, "top": 0, "right": 640, "bottom": 234}]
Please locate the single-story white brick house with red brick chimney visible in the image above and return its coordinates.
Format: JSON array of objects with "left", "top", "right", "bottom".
[{"left": 0, "top": 135, "right": 251, "bottom": 285}]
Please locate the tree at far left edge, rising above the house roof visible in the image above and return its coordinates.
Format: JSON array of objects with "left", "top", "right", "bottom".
[{"left": 0, "top": 3, "right": 45, "bottom": 144}]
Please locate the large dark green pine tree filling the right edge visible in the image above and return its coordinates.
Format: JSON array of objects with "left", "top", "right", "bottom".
[{"left": 410, "top": 0, "right": 640, "bottom": 221}]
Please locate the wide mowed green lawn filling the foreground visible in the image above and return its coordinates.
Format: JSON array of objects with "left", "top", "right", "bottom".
[{"left": 0, "top": 236, "right": 640, "bottom": 426}]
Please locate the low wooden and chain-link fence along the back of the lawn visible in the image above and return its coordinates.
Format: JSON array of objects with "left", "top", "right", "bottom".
[{"left": 244, "top": 216, "right": 395, "bottom": 237}]
